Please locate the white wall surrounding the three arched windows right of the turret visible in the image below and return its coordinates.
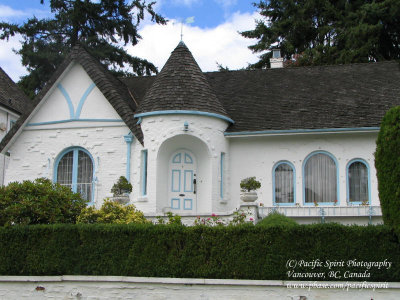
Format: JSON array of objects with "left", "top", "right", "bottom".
[{"left": 229, "top": 133, "right": 379, "bottom": 210}]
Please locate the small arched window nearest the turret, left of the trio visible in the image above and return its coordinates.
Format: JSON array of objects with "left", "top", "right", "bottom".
[{"left": 272, "top": 162, "right": 295, "bottom": 205}]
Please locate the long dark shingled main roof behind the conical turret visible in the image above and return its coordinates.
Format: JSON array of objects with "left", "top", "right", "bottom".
[{"left": 124, "top": 61, "right": 400, "bottom": 132}]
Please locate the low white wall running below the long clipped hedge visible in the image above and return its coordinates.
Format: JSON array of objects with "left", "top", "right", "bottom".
[{"left": 0, "top": 276, "right": 400, "bottom": 300}]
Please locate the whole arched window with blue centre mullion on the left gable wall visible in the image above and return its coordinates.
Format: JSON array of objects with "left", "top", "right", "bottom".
[{"left": 55, "top": 148, "right": 93, "bottom": 202}]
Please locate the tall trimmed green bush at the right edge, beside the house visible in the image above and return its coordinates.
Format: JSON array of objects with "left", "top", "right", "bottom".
[{"left": 375, "top": 107, "right": 400, "bottom": 234}]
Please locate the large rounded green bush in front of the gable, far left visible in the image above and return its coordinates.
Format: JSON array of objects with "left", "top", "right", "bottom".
[{"left": 0, "top": 178, "right": 86, "bottom": 226}]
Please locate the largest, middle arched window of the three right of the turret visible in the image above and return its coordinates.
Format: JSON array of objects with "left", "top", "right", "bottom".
[{"left": 304, "top": 152, "right": 338, "bottom": 204}]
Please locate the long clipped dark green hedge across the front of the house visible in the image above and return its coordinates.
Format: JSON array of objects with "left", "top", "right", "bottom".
[{"left": 0, "top": 224, "right": 400, "bottom": 281}]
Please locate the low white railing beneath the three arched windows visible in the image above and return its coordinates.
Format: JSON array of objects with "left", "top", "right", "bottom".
[{"left": 259, "top": 206, "right": 382, "bottom": 223}]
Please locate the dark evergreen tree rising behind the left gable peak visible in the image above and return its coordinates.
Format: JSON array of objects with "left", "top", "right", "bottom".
[{"left": 0, "top": 0, "right": 166, "bottom": 96}]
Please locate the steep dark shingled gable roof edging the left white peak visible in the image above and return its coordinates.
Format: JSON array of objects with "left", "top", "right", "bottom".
[{"left": 0, "top": 45, "right": 143, "bottom": 151}]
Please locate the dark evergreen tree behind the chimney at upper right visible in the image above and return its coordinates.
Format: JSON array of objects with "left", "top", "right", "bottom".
[{"left": 241, "top": 0, "right": 400, "bottom": 68}]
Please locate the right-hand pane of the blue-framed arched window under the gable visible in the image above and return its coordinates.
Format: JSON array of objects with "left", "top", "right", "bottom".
[{"left": 77, "top": 151, "right": 93, "bottom": 201}]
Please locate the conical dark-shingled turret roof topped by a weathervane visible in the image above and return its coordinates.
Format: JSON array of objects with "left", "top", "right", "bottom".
[{"left": 136, "top": 42, "right": 229, "bottom": 118}]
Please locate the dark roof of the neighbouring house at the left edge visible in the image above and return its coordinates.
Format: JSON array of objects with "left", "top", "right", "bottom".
[{"left": 0, "top": 68, "right": 32, "bottom": 115}]
